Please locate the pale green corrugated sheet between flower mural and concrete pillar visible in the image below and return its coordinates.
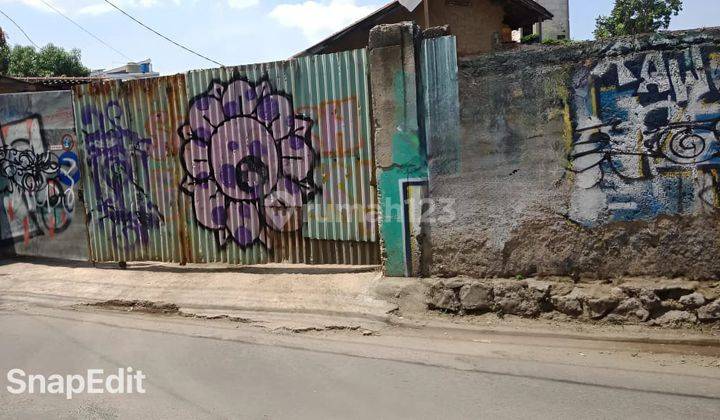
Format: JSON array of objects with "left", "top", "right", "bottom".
[{"left": 293, "top": 50, "right": 377, "bottom": 241}]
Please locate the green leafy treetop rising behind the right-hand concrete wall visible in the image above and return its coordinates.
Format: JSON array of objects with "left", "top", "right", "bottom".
[{"left": 595, "top": 0, "right": 683, "bottom": 39}]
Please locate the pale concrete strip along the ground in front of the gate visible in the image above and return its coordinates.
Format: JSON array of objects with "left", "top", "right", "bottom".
[{"left": 0, "top": 260, "right": 396, "bottom": 320}]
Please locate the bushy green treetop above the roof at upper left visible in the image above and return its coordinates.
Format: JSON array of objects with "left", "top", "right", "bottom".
[{"left": 8, "top": 44, "right": 90, "bottom": 77}]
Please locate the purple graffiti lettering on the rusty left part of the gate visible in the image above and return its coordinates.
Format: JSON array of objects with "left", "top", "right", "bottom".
[{"left": 80, "top": 100, "right": 165, "bottom": 249}]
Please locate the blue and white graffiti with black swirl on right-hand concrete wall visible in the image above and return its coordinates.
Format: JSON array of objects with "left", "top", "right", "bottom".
[{"left": 568, "top": 47, "right": 720, "bottom": 225}]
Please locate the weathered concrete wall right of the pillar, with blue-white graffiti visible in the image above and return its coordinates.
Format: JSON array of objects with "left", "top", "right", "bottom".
[{"left": 427, "top": 29, "right": 720, "bottom": 279}]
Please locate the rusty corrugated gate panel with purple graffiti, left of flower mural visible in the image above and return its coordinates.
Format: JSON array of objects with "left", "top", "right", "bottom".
[{"left": 74, "top": 75, "right": 187, "bottom": 262}]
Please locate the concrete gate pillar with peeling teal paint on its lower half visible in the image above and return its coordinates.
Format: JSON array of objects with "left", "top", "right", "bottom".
[{"left": 369, "top": 22, "right": 428, "bottom": 276}]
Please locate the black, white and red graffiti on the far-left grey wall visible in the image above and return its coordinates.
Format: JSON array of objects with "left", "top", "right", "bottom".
[{"left": 0, "top": 114, "right": 80, "bottom": 245}]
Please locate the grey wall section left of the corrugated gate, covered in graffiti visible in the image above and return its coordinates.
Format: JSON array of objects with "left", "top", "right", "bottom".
[{"left": 0, "top": 91, "right": 88, "bottom": 260}]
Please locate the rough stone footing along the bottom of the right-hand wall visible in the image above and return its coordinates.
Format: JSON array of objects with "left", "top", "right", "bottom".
[{"left": 426, "top": 278, "right": 720, "bottom": 327}]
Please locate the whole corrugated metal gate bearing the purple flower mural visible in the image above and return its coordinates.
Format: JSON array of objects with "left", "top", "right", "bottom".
[{"left": 74, "top": 50, "right": 379, "bottom": 264}]
